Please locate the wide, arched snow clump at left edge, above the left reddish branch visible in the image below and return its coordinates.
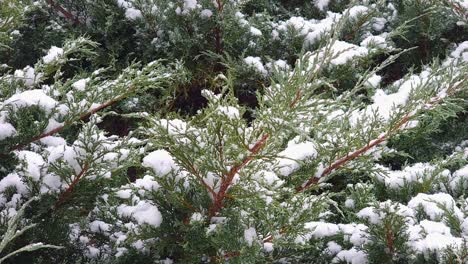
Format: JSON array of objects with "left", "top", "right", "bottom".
[{"left": 5, "top": 89, "right": 58, "bottom": 113}]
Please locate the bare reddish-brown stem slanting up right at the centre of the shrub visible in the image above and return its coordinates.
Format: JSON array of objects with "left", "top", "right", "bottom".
[{"left": 209, "top": 134, "right": 270, "bottom": 218}]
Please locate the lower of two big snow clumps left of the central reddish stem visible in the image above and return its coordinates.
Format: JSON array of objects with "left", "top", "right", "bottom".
[{"left": 117, "top": 201, "right": 162, "bottom": 227}]
